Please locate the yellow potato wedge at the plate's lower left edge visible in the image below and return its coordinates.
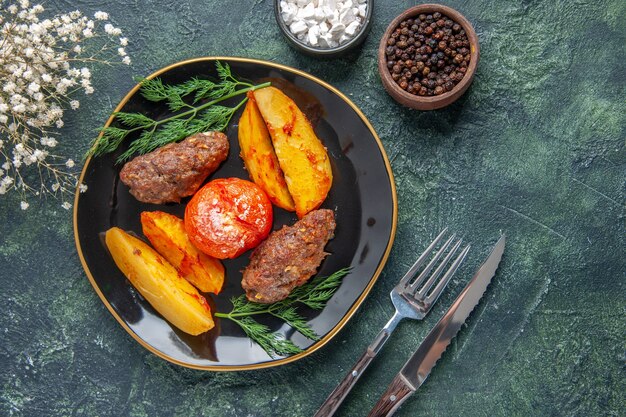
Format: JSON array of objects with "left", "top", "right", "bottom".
[{"left": 105, "top": 227, "right": 214, "bottom": 335}]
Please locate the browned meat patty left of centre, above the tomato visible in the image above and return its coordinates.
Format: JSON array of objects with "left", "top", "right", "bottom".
[{"left": 120, "top": 132, "right": 229, "bottom": 204}]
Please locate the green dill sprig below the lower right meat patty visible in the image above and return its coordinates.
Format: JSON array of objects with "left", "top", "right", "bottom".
[{"left": 215, "top": 268, "right": 350, "bottom": 357}]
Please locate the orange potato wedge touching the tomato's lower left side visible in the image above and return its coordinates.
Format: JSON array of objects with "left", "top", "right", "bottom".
[{"left": 141, "top": 211, "right": 224, "bottom": 294}]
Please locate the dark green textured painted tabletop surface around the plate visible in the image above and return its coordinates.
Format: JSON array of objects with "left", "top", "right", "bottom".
[{"left": 0, "top": 0, "right": 626, "bottom": 417}]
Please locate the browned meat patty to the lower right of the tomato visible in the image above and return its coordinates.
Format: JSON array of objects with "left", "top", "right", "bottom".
[{"left": 241, "top": 209, "right": 335, "bottom": 304}]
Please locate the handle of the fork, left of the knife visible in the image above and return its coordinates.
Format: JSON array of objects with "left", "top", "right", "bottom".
[{"left": 314, "top": 312, "right": 402, "bottom": 417}]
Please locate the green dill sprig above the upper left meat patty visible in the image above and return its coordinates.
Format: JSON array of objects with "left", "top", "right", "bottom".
[{"left": 89, "top": 61, "right": 270, "bottom": 163}]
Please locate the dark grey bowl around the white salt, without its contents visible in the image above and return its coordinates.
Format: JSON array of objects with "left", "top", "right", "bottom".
[{"left": 274, "top": 0, "right": 374, "bottom": 58}]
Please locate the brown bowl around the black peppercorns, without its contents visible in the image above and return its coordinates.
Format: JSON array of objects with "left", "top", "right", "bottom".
[{"left": 378, "top": 4, "right": 480, "bottom": 110}]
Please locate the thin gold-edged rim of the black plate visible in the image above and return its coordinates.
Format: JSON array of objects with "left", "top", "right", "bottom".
[{"left": 73, "top": 56, "right": 398, "bottom": 371}]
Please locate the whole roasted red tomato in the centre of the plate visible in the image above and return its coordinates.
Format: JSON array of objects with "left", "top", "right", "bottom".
[{"left": 185, "top": 178, "right": 273, "bottom": 259}]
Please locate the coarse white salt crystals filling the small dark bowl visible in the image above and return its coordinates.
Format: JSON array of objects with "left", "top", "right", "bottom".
[{"left": 280, "top": 0, "right": 368, "bottom": 48}]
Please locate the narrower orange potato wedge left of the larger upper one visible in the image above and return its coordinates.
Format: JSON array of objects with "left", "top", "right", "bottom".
[{"left": 238, "top": 93, "right": 296, "bottom": 211}]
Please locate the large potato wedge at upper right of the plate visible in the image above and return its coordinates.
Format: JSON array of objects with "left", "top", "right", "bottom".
[{"left": 253, "top": 87, "right": 333, "bottom": 218}]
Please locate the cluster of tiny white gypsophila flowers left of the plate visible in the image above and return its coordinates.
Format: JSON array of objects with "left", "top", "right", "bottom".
[{"left": 0, "top": 0, "right": 131, "bottom": 209}]
